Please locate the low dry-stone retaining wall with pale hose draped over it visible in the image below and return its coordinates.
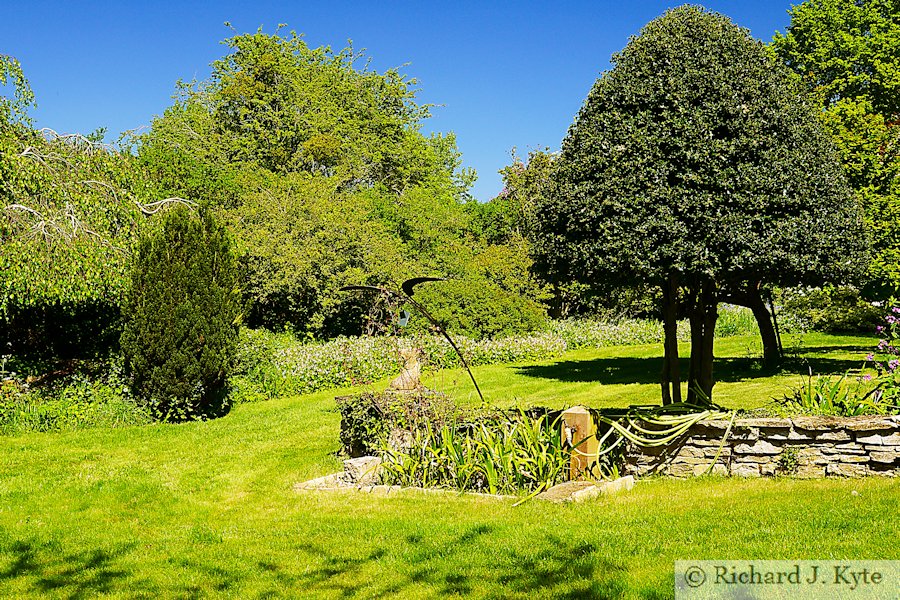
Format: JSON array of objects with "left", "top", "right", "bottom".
[{"left": 625, "top": 416, "right": 900, "bottom": 478}]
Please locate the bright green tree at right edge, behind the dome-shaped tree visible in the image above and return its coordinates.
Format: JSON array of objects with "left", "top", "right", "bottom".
[{"left": 772, "top": 0, "right": 900, "bottom": 297}]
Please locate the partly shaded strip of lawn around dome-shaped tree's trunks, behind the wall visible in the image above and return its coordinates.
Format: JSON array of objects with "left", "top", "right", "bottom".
[{"left": 425, "top": 333, "right": 878, "bottom": 409}]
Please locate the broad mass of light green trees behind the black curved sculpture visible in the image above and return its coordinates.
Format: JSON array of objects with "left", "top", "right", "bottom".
[{"left": 137, "top": 31, "right": 540, "bottom": 337}]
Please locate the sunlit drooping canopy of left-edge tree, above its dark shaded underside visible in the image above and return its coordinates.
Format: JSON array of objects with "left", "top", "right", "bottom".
[{"left": 0, "top": 56, "right": 152, "bottom": 314}]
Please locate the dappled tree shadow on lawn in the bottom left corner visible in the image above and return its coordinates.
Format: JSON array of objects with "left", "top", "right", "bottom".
[{"left": 0, "top": 540, "right": 135, "bottom": 598}]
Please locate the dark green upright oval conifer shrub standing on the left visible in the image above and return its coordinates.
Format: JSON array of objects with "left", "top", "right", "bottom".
[{"left": 122, "top": 207, "right": 240, "bottom": 420}]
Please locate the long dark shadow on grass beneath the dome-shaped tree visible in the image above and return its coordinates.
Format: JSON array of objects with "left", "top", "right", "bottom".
[{"left": 516, "top": 348, "right": 862, "bottom": 385}]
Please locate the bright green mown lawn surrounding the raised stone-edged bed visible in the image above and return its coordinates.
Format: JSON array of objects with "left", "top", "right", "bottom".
[{"left": 0, "top": 337, "right": 900, "bottom": 598}]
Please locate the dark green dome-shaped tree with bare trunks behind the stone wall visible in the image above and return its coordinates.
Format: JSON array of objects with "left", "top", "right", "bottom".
[{"left": 534, "top": 6, "right": 865, "bottom": 402}]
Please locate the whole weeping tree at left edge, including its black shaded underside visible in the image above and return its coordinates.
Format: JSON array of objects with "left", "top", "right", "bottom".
[{"left": 0, "top": 56, "right": 159, "bottom": 359}]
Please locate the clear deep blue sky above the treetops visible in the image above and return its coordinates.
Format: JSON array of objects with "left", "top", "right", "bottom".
[{"left": 0, "top": 0, "right": 798, "bottom": 200}]
